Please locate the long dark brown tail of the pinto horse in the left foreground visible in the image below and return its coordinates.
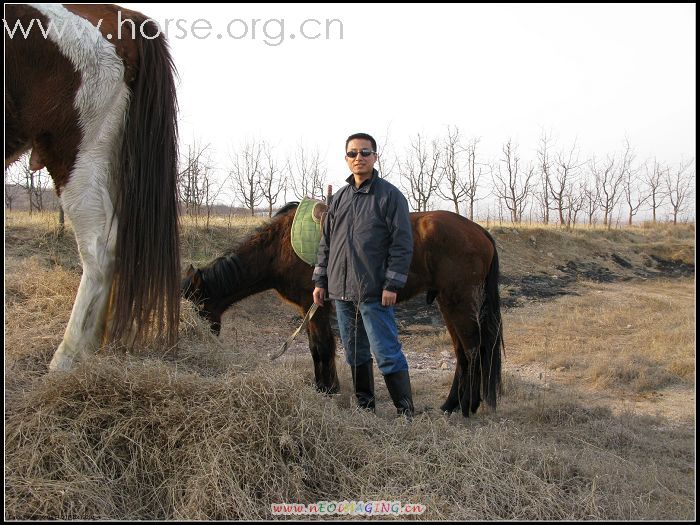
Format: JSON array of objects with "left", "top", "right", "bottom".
[{"left": 109, "top": 15, "right": 180, "bottom": 342}]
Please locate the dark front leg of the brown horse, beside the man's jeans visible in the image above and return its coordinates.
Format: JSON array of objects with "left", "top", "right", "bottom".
[{"left": 306, "top": 302, "right": 340, "bottom": 394}]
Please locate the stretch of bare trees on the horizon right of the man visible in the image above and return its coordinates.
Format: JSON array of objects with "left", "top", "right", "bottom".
[{"left": 397, "top": 128, "right": 695, "bottom": 227}]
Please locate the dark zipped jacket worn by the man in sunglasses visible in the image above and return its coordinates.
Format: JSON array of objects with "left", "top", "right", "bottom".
[{"left": 313, "top": 170, "right": 413, "bottom": 302}]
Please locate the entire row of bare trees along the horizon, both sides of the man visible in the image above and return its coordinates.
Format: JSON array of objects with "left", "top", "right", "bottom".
[{"left": 5, "top": 132, "right": 695, "bottom": 227}]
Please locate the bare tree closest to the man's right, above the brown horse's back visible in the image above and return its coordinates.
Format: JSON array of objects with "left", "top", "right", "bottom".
[{"left": 399, "top": 133, "right": 441, "bottom": 211}]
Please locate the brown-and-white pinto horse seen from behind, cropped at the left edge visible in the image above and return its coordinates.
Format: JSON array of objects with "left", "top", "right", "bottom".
[{"left": 5, "top": 4, "right": 180, "bottom": 370}]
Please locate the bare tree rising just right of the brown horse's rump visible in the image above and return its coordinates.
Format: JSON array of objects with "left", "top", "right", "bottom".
[{"left": 492, "top": 139, "right": 535, "bottom": 223}]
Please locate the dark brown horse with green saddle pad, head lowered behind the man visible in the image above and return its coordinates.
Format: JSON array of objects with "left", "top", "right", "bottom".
[{"left": 182, "top": 203, "right": 503, "bottom": 417}]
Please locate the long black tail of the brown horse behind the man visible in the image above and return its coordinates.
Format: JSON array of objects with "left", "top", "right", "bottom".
[{"left": 479, "top": 230, "right": 503, "bottom": 408}]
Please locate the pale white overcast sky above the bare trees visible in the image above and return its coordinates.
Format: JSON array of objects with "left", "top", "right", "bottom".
[{"left": 124, "top": 3, "right": 696, "bottom": 209}]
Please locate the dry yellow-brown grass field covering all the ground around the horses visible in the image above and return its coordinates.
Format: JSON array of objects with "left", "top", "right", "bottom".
[{"left": 5, "top": 212, "right": 696, "bottom": 520}]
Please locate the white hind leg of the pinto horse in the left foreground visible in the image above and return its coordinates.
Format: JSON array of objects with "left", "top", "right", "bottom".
[{"left": 25, "top": 5, "right": 138, "bottom": 370}]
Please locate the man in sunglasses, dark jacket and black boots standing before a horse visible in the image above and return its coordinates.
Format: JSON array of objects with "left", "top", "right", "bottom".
[{"left": 313, "top": 133, "right": 413, "bottom": 418}]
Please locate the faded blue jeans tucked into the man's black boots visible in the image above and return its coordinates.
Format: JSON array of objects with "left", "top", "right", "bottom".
[{"left": 335, "top": 300, "right": 408, "bottom": 375}]
